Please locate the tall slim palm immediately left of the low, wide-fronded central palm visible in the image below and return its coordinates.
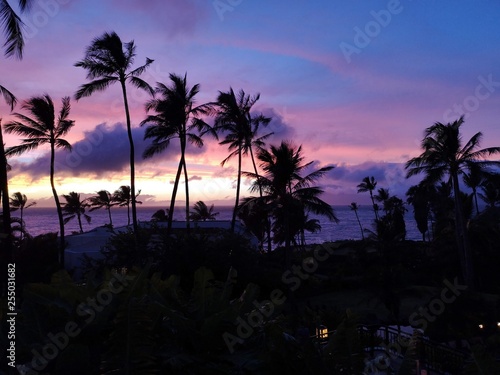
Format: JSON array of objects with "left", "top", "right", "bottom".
[{"left": 214, "top": 88, "right": 272, "bottom": 232}]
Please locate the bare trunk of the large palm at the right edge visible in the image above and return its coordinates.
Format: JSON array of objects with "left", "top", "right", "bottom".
[{"left": 452, "top": 173, "right": 474, "bottom": 289}]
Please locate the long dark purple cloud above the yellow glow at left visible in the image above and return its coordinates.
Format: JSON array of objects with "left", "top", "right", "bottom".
[{"left": 11, "top": 123, "right": 204, "bottom": 180}]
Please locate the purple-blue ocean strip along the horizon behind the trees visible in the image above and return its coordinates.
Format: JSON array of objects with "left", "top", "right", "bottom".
[{"left": 17, "top": 205, "right": 422, "bottom": 244}]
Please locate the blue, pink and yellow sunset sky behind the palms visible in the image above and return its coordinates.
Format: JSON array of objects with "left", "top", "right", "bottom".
[{"left": 0, "top": 0, "right": 500, "bottom": 206}]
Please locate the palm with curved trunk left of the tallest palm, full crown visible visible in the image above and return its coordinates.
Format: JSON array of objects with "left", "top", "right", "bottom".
[{"left": 5, "top": 94, "right": 75, "bottom": 264}]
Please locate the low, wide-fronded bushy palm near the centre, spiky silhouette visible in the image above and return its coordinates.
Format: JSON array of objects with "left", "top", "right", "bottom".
[{"left": 245, "top": 141, "right": 338, "bottom": 267}]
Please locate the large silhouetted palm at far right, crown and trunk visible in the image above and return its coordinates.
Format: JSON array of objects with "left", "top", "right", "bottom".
[{"left": 406, "top": 116, "right": 500, "bottom": 287}]
